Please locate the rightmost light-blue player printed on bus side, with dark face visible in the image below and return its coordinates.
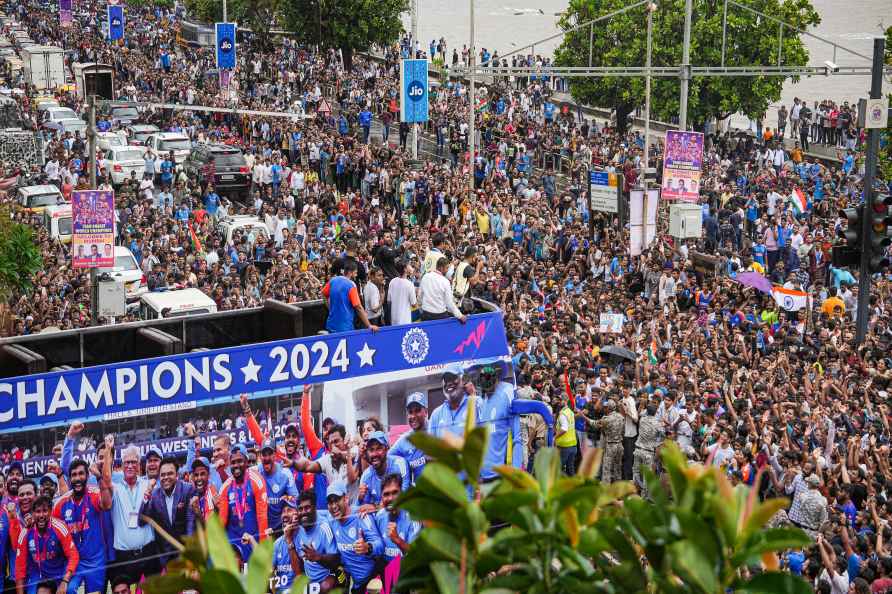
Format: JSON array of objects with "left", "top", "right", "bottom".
[{"left": 478, "top": 364, "right": 523, "bottom": 482}]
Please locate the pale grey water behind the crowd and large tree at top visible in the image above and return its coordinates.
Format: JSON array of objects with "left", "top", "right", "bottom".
[{"left": 405, "top": 0, "right": 892, "bottom": 125}]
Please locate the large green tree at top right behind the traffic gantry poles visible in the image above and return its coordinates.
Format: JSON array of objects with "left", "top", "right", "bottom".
[{"left": 555, "top": 0, "right": 820, "bottom": 130}]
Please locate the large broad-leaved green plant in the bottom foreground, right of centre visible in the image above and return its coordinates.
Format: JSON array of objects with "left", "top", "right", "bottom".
[{"left": 397, "top": 427, "right": 812, "bottom": 594}]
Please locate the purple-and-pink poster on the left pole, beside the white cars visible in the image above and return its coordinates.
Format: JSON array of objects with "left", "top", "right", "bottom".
[{"left": 71, "top": 190, "right": 115, "bottom": 268}]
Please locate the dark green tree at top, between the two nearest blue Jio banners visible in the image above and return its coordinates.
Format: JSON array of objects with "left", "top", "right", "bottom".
[{"left": 282, "top": 0, "right": 409, "bottom": 70}]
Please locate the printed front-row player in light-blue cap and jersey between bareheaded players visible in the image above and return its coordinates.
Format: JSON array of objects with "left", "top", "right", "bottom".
[{"left": 326, "top": 483, "right": 384, "bottom": 594}]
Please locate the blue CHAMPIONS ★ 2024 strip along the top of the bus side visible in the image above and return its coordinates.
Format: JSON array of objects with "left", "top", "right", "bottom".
[{"left": 0, "top": 312, "right": 509, "bottom": 433}]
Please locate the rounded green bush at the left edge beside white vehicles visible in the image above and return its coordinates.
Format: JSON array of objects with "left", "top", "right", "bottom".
[{"left": 0, "top": 208, "right": 43, "bottom": 302}]
